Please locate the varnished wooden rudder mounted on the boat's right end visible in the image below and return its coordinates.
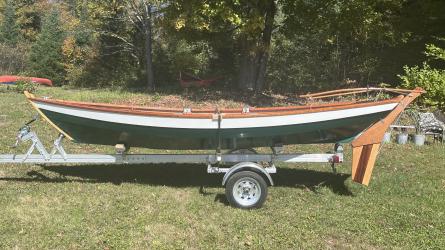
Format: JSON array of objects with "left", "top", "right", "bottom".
[{"left": 351, "top": 88, "right": 425, "bottom": 186}]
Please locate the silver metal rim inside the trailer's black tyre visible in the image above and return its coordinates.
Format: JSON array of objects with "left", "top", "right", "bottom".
[{"left": 233, "top": 177, "right": 261, "bottom": 206}]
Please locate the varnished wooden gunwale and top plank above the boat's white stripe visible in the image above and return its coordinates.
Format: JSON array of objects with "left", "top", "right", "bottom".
[{"left": 28, "top": 96, "right": 403, "bottom": 119}]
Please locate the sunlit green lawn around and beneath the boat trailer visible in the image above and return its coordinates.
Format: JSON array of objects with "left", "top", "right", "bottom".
[{"left": 0, "top": 88, "right": 445, "bottom": 249}]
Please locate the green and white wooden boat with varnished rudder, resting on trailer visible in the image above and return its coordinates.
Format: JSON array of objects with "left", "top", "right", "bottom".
[{"left": 25, "top": 88, "right": 423, "bottom": 184}]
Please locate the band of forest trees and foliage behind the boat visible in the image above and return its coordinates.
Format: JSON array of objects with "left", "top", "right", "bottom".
[{"left": 0, "top": 0, "right": 445, "bottom": 109}]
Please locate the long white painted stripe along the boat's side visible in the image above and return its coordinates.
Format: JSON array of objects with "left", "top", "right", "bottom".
[{"left": 34, "top": 101, "right": 398, "bottom": 129}]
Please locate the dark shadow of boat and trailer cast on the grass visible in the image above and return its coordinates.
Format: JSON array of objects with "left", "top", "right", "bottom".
[{"left": 0, "top": 164, "right": 352, "bottom": 196}]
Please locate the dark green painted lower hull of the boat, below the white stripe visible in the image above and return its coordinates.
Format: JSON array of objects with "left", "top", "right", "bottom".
[{"left": 42, "top": 109, "right": 389, "bottom": 150}]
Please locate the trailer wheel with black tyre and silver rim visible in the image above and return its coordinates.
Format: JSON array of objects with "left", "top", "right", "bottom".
[{"left": 226, "top": 171, "right": 267, "bottom": 209}]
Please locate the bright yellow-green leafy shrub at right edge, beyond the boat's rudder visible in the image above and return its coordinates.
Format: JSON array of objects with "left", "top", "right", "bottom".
[{"left": 399, "top": 40, "right": 445, "bottom": 111}]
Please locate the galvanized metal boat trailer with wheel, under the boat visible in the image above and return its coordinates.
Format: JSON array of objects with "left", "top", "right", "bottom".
[{"left": 0, "top": 117, "right": 343, "bottom": 209}]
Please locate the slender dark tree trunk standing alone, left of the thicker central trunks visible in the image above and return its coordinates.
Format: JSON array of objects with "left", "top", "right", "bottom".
[{"left": 144, "top": 3, "right": 155, "bottom": 91}]
